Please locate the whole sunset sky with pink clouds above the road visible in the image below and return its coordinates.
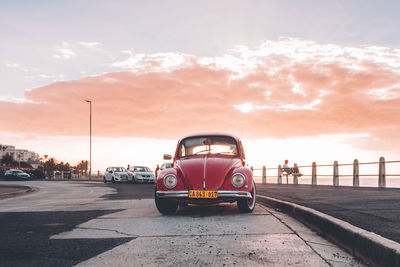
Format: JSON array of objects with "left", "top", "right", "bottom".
[{"left": 0, "top": 0, "right": 400, "bottom": 171}]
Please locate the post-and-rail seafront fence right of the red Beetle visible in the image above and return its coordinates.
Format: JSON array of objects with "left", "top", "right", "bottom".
[{"left": 250, "top": 157, "right": 400, "bottom": 188}]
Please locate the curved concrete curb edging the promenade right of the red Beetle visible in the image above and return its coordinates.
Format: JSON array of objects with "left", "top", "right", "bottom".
[{"left": 257, "top": 195, "right": 400, "bottom": 266}]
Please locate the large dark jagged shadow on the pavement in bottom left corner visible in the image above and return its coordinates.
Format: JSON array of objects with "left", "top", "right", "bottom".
[{"left": 0, "top": 209, "right": 133, "bottom": 266}]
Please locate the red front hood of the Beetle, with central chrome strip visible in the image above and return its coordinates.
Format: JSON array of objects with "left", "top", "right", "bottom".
[{"left": 176, "top": 155, "right": 241, "bottom": 190}]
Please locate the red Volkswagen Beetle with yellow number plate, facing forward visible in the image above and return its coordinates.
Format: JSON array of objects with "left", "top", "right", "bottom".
[{"left": 154, "top": 133, "right": 256, "bottom": 214}]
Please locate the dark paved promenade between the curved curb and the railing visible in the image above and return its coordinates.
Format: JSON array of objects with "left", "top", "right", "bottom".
[{"left": 257, "top": 184, "right": 400, "bottom": 242}]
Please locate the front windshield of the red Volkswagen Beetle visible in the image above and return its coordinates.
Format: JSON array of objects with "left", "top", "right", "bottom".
[{"left": 178, "top": 136, "right": 238, "bottom": 157}]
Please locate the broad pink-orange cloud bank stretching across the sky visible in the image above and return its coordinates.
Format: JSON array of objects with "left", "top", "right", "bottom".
[{"left": 0, "top": 39, "right": 400, "bottom": 151}]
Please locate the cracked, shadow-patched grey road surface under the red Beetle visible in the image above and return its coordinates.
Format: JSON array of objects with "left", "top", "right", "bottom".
[{"left": 0, "top": 181, "right": 363, "bottom": 266}]
